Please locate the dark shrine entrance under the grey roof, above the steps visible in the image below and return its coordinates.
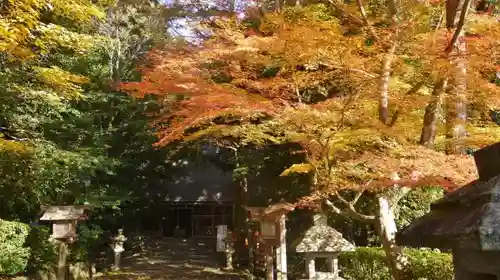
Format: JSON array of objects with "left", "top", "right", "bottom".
[{"left": 161, "top": 202, "right": 233, "bottom": 238}]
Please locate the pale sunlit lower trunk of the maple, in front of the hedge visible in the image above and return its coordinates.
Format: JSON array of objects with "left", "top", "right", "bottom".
[{"left": 376, "top": 195, "right": 408, "bottom": 280}]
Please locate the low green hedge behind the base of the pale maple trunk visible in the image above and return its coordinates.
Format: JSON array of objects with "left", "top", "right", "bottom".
[{"left": 339, "top": 247, "right": 453, "bottom": 280}]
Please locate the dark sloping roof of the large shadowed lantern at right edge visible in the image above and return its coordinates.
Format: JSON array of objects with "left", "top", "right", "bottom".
[{"left": 397, "top": 143, "right": 500, "bottom": 251}]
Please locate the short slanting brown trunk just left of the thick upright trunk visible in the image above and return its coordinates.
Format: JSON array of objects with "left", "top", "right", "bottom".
[{"left": 419, "top": 78, "right": 448, "bottom": 148}]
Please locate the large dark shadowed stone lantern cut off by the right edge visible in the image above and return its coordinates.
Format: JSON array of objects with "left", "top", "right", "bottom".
[{"left": 397, "top": 143, "right": 500, "bottom": 280}]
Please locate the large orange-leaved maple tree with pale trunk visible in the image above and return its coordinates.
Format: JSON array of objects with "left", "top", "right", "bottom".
[{"left": 121, "top": 1, "right": 500, "bottom": 279}]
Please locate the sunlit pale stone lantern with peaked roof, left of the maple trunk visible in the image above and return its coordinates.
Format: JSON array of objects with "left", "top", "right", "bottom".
[{"left": 294, "top": 214, "right": 355, "bottom": 280}]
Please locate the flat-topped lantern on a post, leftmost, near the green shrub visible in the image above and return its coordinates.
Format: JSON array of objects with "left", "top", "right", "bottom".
[{"left": 40, "top": 205, "right": 90, "bottom": 280}]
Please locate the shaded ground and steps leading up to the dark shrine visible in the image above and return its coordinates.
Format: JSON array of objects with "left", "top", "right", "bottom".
[{"left": 97, "top": 238, "right": 244, "bottom": 280}]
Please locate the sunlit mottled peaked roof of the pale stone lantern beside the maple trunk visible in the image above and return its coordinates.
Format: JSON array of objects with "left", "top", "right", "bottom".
[{"left": 294, "top": 214, "right": 355, "bottom": 253}]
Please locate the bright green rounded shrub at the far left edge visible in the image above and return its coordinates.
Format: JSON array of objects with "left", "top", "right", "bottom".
[{"left": 0, "top": 220, "right": 30, "bottom": 275}]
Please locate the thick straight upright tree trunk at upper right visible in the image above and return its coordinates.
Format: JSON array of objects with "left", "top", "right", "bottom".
[{"left": 445, "top": 0, "right": 471, "bottom": 154}]
